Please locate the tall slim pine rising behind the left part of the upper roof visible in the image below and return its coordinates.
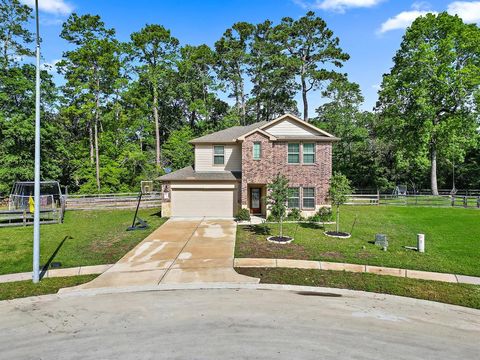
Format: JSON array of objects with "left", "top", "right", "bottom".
[{"left": 215, "top": 22, "right": 251, "bottom": 125}]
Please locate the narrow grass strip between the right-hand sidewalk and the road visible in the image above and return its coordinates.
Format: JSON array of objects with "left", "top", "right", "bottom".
[{"left": 235, "top": 268, "right": 480, "bottom": 309}]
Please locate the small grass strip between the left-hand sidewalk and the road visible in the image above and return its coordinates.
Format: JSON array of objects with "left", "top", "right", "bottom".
[{"left": 0, "top": 275, "right": 97, "bottom": 300}]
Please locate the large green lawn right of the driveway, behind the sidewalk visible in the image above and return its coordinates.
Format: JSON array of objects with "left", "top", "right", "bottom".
[{"left": 235, "top": 206, "right": 480, "bottom": 276}]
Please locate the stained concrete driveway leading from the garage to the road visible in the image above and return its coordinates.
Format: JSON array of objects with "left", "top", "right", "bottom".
[{"left": 71, "top": 218, "right": 259, "bottom": 289}]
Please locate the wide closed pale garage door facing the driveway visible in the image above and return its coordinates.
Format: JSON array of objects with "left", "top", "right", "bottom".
[{"left": 171, "top": 189, "right": 234, "bottom": 217}]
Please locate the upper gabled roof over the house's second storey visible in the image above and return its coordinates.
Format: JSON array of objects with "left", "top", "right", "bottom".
[{"left": 189, "top": 114, "right": 339, "bottom": 144}]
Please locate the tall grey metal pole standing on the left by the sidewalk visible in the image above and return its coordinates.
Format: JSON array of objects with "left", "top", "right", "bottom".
[{"left": 32, "top": 0, "right": 40, "bottom": 283}]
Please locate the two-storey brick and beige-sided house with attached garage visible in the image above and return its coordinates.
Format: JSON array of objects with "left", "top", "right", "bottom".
[{"left": 159, "top": 114, "right": 339, "bottom": 217}]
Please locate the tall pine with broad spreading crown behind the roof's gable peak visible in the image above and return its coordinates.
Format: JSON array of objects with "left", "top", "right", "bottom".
[{"left": 275, "top": 11, "right": 350, "bottom": 121}]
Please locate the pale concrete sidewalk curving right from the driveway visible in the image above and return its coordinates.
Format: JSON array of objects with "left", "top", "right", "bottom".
[{"left": 234, "top": 258, "right": 480, "bottom": 285}]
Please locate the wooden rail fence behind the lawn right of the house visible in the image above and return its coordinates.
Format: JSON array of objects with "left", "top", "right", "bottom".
[{"left": 346, "top": 193, "right": 480, "bottom": 209}]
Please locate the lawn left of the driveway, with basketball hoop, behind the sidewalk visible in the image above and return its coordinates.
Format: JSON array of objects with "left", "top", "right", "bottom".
[{"left": 0, "top": 209, "right": 166, "bottom": 274}]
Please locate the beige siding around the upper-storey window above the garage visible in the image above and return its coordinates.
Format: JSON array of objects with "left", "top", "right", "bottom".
[{"left": 195, "top": 144, "right": 242, "bottom": 171}]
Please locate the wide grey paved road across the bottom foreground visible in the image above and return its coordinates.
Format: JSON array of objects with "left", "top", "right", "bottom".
[{"left": 0, "top": 289, "right": 480, "bottom": 360}]
